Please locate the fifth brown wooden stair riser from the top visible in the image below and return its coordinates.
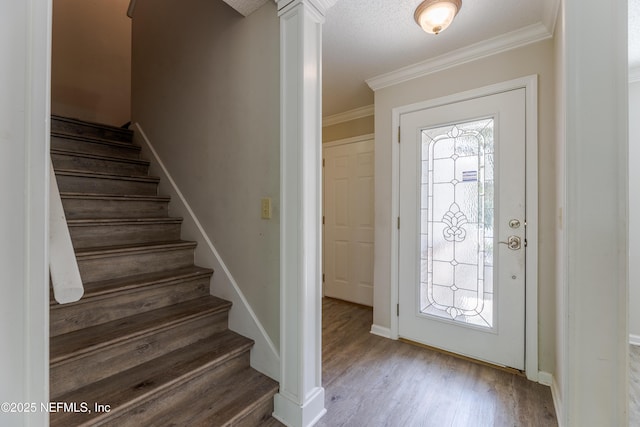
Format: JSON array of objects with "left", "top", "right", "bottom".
[{"left": 62, "top": 196, "right": 169, "bottom": 219}]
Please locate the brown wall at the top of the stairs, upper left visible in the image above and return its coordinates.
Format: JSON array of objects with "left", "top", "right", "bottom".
[{"left": 51, "top": 0, "right": 131, "bottom": 126}]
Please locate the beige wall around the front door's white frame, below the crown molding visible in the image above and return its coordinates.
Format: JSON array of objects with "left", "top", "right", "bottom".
[{"left": 373, "top": 40, "right": 557, "bottom": 373}]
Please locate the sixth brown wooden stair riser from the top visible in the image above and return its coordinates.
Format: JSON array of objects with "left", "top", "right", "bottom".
[{"left": 69, "top": 223, "right": 180, "bottom": 249}]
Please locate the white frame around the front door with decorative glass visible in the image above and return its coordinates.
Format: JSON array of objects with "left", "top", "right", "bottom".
[{"left": 389, "top": 74, "right": 538, "bottom": 382}]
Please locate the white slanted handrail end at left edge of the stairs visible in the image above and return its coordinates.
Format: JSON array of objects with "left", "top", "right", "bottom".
[{"left": 49, "top": 161, "right": 84, "bottom": 304}]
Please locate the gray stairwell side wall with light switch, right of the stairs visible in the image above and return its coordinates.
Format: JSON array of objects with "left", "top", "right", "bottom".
[{"left": 132, "top": 0, "right": 280, "bottom": 348}]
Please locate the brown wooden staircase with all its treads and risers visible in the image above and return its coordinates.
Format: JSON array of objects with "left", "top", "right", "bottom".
[{"left": 50, "top": 117, "right": 280, "bottom": 427}]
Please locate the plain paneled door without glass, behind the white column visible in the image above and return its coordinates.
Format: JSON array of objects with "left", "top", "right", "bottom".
[{"left": 323, "top": 140, "right": 374, "bottom": 306}]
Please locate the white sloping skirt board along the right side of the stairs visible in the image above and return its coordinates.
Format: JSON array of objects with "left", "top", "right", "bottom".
[{"left": 133, "top": 123, "right": 280, "bottom": 381}]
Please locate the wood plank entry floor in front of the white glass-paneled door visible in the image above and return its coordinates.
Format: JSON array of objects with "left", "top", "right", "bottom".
[{"left": 317, "top": 298, "right": 557, "bottom": 427}]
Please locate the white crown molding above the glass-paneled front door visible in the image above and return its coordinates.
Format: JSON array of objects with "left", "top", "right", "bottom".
[{"left": 366, "top": 22, "right": 552, "bottom": 91}]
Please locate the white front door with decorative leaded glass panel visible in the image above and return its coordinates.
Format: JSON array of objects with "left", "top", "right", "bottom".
[{"left": 398, "top": 89, "right": 526, "bottom": 370}]
